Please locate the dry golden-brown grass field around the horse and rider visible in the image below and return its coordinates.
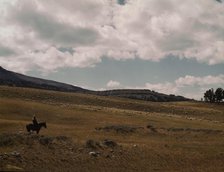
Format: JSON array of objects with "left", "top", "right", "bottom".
[{"left": 0, "top": 87, "right": 224, "bottom": 172}]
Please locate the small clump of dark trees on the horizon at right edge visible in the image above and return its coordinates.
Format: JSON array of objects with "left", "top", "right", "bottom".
[{"left": 204, "top": 88, "right": 224, "bottom": 103}]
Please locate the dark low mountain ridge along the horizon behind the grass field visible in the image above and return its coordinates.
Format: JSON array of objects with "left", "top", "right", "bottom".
[{"left": 0, "top": 66, "right": 190, "bottom": 102}]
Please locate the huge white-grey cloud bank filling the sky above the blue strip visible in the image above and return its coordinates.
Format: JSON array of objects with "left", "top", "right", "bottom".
[{"left": 0, "top": 0, "right": 224, "bottom": 72}]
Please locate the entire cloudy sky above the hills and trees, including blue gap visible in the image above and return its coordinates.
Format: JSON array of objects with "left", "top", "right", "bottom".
[{"left": 0, "top": 0, "right": 224, "bottom": 99}]
